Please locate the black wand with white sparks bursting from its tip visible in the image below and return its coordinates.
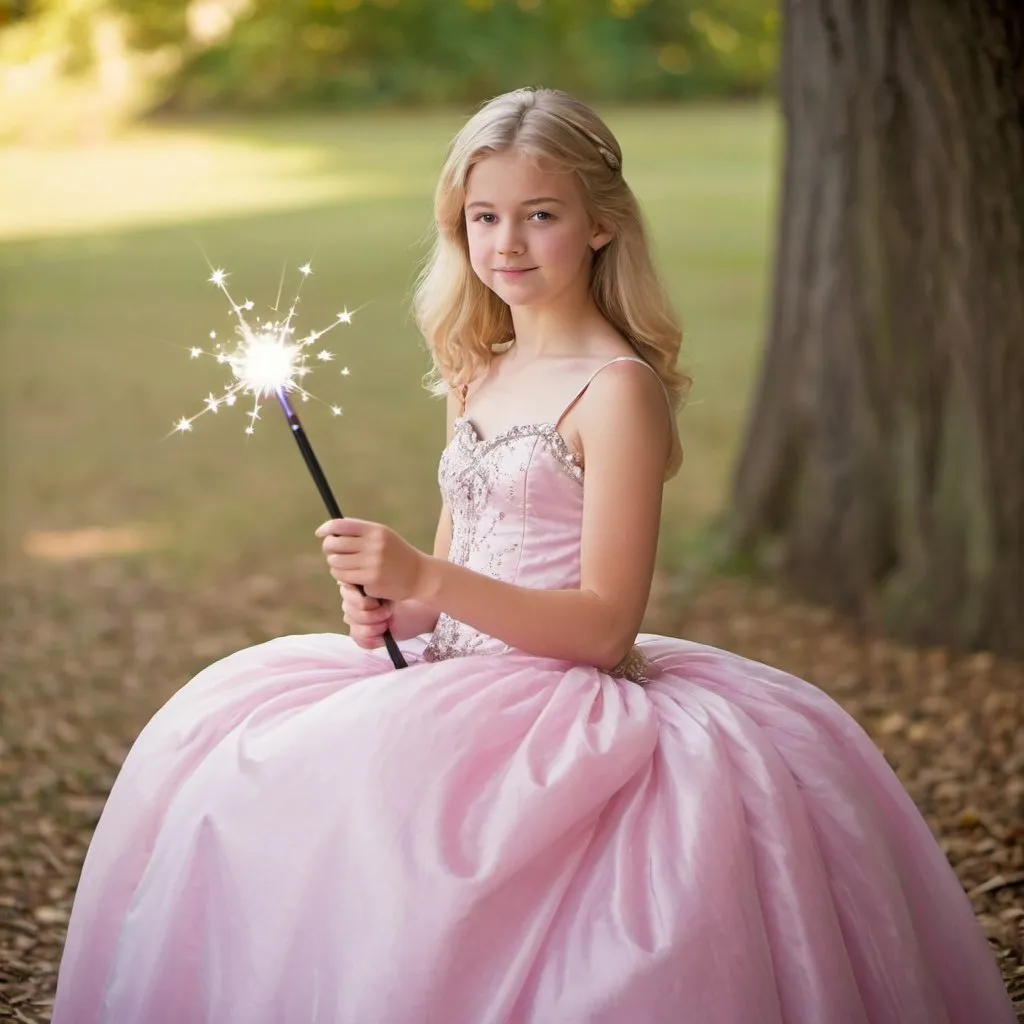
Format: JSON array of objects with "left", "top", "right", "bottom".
[{"left": 173, "top": 263, "right": 407, "bottom": 669}]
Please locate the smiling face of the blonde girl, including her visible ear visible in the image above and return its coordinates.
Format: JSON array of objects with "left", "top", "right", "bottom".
[{"left": 464, "top": 150, "right": 611, "bottom": 306}]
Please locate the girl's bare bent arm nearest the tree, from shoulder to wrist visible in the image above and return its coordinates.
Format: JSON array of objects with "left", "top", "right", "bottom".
[{"left": 414, "top": 362, "right": 674, "bottom": 670}]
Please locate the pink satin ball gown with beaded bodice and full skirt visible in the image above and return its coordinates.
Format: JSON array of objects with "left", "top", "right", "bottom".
[{"left": 53, "top": 362, "right": 1014, "bottom": 1024}]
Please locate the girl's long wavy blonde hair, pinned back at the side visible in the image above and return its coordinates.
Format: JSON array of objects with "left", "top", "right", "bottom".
[{"left": 413, "top": 89, "right": 689, "bottom": 408}]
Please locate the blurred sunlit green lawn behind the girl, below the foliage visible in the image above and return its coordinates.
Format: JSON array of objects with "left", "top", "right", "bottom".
[{"left": 0, "top": 105, "right": 777, "bottom": 579}]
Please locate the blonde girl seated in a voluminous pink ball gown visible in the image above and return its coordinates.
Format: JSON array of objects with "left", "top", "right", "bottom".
[{"left": 53, "top": 90, "right": 1013, "bottom": 1024}]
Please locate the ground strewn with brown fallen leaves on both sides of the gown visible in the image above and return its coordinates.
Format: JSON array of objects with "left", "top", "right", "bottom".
[{"left": 0, "top": 558, "right": 1024, "bottom": 1024}]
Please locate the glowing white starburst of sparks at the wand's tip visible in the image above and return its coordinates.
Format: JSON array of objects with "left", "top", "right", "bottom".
[{"left": 172, "top": 263, "right": 352, "bottom": 434}]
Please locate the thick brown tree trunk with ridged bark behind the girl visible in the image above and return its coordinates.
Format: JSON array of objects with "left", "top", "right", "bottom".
[{"left": 730, "top": 0, "right": 1024, "bottom": 653}]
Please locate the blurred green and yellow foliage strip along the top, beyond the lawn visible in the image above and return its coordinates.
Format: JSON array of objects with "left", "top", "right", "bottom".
[{"left": 0, "top": 0, "right": 778, "bottom": 136}]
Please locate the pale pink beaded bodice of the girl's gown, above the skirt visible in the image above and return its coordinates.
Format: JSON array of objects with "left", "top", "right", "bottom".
[{"left": 426, "top": 418, "right": 583, "bottom": 659}]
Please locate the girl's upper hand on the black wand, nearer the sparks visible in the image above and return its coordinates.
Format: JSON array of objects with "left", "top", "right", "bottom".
[{"left": 316, "top": 519, "right": 427, "bottom": 601}]
